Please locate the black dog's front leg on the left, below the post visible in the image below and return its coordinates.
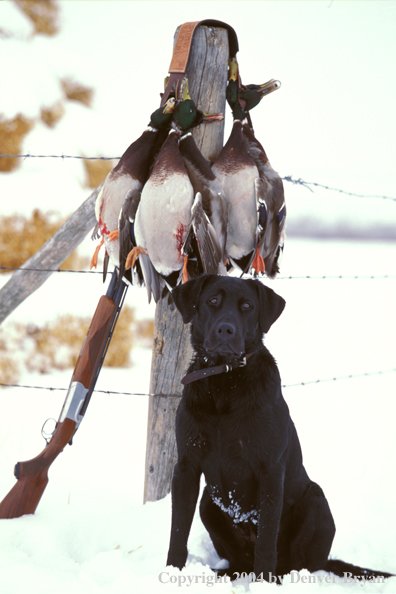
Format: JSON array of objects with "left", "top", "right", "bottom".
[{"left": 166, "top": 460, "right": 201, "bottom": 569}]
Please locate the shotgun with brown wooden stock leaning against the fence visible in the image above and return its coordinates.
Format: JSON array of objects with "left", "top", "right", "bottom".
[{"left": 0, "top": 268, "right": 128, "bottom": 519}]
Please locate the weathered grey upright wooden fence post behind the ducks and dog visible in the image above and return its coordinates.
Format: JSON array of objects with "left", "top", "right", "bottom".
[{"left": 144, "top": 26, "right": 229, "bottom": 502}]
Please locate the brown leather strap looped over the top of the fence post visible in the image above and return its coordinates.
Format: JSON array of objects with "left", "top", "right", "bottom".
[{"left": 161, "top": 19, "right": 239, "bottom": 107}]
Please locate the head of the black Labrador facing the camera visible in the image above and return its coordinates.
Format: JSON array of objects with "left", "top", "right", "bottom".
[{"left": 172, "top": 274, "right": 285, "bottom": 362}]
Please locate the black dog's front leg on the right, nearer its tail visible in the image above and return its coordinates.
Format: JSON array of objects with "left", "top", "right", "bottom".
[{"left": 254, "top": 464, "right": 284, "bottom": 581}]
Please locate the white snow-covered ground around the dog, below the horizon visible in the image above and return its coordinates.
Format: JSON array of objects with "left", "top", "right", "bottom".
[{"left": 0, "top": 239, "right": 396, "bottom": 594}]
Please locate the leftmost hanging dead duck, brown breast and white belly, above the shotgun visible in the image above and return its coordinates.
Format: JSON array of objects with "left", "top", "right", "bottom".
[{"left": 91, "top": 98, "right": 175, "bottom": 282}]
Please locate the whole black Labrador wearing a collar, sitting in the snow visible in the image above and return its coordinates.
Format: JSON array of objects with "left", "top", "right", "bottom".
[{"left": 167, "top": 275, "right": 390, "bottom": 581}]
